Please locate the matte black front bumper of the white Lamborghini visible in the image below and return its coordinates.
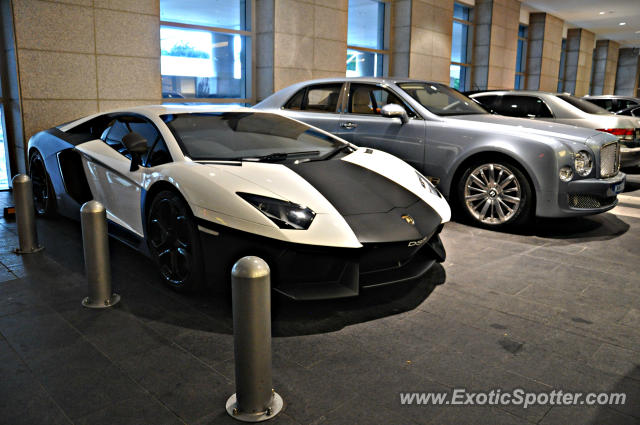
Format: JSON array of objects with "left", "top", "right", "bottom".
[{"left": 198, "top": 220, "right": 446, "bottom": 300}]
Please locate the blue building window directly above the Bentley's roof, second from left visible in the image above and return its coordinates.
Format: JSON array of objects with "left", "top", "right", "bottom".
[{"left": 347, "top": 0, "right": 389, "bottom": 77}]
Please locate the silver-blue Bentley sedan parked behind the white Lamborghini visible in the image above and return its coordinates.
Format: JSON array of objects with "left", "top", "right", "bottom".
[{"left": 255, "top": 78, "right": 625, "bottom": 227}]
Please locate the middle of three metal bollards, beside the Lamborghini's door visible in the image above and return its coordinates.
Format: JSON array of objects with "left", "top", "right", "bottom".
[{"left": 80, "top": 201, "right": 120, "bottom": 308}]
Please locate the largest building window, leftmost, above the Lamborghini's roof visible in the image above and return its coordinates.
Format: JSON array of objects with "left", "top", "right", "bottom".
[{"left": 160, "top": 0, "right": 253, "bottom": 103}]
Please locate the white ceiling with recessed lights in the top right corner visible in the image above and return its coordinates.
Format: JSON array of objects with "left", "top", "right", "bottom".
[{"left": 522, "top": 0, "right": 640, "bottom": 47}]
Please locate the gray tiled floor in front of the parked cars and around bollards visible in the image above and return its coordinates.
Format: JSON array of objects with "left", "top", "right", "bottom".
[{"left": 0, "top": 172, "right": 640, "bottom": 425}]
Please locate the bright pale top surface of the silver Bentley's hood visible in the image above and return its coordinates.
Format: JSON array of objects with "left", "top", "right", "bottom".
[{"left": 448, "top": 114, "right": 599, "bottom": 142}]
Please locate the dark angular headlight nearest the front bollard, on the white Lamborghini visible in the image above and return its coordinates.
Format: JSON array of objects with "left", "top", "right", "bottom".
[{"left": 237, "top": 192, "right": 316, "bottom": 230}]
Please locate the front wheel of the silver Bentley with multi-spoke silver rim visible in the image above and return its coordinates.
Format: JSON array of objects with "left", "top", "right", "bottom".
[{"left": 455, "top": 158, "right": 533, "bottom": 229}]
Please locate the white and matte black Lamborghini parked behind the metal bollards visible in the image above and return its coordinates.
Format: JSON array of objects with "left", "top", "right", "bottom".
[{"left": 29, "top": 106, "right": 450, "bottom": 299}]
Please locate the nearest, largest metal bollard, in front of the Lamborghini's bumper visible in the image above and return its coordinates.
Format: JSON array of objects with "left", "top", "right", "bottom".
[{"left": 226, "top": 257, "right": 283, "bottom": 422}]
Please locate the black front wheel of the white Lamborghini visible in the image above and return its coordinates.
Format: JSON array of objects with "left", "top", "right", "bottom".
[{"left": 147, "top": 190, "right": 204, "bottom": 292}]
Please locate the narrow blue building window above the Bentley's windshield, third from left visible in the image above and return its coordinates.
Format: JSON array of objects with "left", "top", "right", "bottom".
[{"left": 449, "top": 3, "right": 473, "bottom": 91}]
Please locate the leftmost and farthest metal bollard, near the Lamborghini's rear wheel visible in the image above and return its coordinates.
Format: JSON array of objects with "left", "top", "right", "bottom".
[{"left": 12, "top": 174, "right": 43, "bottom": 254}]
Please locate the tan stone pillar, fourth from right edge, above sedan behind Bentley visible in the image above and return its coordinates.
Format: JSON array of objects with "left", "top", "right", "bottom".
[{"left": 526, "top": 12, "right": 564, "bottom": 92}]
